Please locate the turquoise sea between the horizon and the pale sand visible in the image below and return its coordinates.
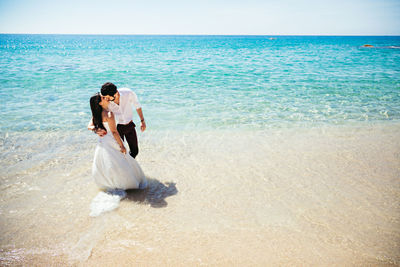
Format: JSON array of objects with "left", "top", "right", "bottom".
[{"left": 0, "top": 34, "right": 400, "bottom": 134}]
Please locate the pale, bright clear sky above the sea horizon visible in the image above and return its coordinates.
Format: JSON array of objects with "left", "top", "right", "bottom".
[{"left": 0, "top": 0, "right": 400, "bottom": 35}]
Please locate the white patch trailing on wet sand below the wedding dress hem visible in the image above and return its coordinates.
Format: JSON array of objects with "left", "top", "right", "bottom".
[{"left": 89, "top": 189, "right": 126, "bottom": 217}]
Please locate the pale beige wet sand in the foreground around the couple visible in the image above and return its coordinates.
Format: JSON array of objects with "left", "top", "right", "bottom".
[{"left": 0, "top": 123, "right": 400, "bottom": 266}]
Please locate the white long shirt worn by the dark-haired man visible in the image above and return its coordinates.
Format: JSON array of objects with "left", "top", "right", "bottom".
[{"left": 108, "top": 88, "right": 142, "bottom": 124}]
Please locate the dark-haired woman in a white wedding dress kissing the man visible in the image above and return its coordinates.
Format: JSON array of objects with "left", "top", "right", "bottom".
[{"left": 88, "top": 94, "right": 147, "bottom": 191}]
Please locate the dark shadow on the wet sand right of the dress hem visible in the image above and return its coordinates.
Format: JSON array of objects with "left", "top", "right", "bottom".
[{"left": 126, "top": 177, "right": 178, "bottom": 208}]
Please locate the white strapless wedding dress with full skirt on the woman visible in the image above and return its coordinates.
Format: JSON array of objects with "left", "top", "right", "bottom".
[{"left": 92, "top": 122, "right": 147, "bottom": 190}]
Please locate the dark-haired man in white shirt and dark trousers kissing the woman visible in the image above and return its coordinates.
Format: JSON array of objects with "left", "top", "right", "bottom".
[{"left": 98, "top": 82, "right": 146, "bottom": 158}]
